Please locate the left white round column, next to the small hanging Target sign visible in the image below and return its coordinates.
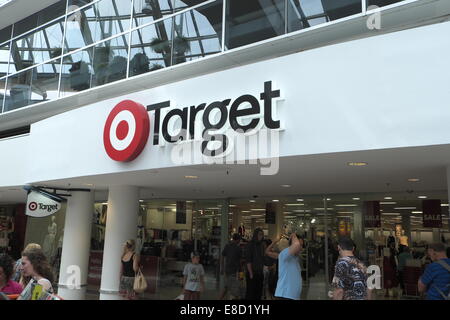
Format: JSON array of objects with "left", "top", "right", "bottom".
[{"left": 58, "top": 191, "right": 94, "bottom": 300}]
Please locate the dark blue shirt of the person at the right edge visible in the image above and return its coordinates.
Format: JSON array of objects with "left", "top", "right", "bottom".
[{"left": 420, "top": 258, "right": 450, "bottom": 300}]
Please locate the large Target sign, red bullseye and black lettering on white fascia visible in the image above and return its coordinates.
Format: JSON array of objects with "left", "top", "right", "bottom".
[{"left": 103, "top": 81, "right": 281, "bottom": 162}]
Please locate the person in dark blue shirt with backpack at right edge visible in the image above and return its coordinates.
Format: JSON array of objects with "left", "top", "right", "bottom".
[{"left": 418, "top": 243, "right": 450, "bottom": 300}]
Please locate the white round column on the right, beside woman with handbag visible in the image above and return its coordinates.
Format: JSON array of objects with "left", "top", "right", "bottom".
[{"left": 100, "top": 186, "right": 139, "bottom": 300}]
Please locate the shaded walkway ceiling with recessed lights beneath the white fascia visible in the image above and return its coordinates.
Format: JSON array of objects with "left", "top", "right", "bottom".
[{"left": 0, "top": 145, "right": 450, "bottom": 203}]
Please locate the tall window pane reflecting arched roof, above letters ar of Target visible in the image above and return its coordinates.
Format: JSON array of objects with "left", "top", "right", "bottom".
[{"left": 173, "top": 1, "right": 222, "bottom": 64}]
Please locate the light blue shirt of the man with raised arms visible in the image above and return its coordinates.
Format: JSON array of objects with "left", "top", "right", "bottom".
[{"left": 275, "top": 248, "right": 302, "bottom": 300}]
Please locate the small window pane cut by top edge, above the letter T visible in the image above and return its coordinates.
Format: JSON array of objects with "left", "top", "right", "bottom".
[{"left": 133, "top": 0, "right": 173, "bottom": 27}]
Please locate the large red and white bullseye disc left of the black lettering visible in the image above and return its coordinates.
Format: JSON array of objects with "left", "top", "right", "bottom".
[{"left": 103, "top": 100, "right": 150, "bottom": 162}]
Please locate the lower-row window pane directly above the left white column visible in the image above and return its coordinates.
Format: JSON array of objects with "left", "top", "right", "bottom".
[{"left": 60, "top": 47, "right": 94, "bottom": 97}]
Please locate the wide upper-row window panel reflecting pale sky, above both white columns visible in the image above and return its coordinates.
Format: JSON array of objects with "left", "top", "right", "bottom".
[{"left": 66, "top": 0, "right": 131, "bottom": 52}]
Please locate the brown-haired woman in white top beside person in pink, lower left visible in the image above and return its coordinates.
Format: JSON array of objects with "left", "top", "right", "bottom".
[{"left": 17, "top": 249, "right": 54, "bottom": 300}]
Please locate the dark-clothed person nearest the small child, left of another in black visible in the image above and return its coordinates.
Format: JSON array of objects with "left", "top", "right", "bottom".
[{"left": 220, "top": 233, "right": 241, "bottom": 300}]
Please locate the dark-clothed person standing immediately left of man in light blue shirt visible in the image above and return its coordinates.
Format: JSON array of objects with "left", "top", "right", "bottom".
[{"left": 245, "top": 228, "right": 266, "bottom": 300}]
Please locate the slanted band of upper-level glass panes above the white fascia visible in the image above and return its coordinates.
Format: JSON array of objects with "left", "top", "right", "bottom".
[{"left": 0, "top": 0, "right": 410, "bottom": 112}]
